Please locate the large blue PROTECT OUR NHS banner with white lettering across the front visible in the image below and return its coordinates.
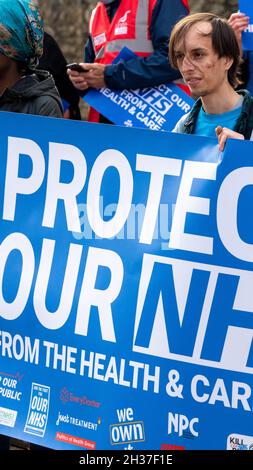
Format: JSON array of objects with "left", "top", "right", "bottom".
[{"left": 0, "top": 113, "right": 253, "bottom": 450}]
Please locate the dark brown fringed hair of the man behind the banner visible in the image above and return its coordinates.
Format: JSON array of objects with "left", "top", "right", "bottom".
[{"left": 169, "top": 13, "right": 241, "bottom": 87}]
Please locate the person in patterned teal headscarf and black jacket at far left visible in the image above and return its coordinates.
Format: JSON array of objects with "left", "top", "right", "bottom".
[{"left": 0, "top": 0, "right": 62, "bottom": 117}]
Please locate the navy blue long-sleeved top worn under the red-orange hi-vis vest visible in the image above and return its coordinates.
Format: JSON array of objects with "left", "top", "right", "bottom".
[{"left": 84, "top": 0, "right": 188, "bottom": 90}]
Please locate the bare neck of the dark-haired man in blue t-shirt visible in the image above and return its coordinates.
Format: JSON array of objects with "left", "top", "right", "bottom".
[{"left": 201, "top": 83, "right": 240, "bottom": 114}]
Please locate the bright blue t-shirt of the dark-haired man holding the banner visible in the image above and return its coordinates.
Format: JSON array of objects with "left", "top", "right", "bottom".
[{"left": 194, "top": 100, "right": 242, "bottom": 137}]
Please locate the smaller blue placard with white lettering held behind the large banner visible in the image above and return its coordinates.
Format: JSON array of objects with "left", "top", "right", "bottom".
[{"left": 83, "top": 47, "right": 194, "bottom": 131}]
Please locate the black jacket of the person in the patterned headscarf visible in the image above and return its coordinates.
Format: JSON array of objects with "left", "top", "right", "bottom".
[{"left": 0, "top": 70, "right": 63, "bottom": 117}]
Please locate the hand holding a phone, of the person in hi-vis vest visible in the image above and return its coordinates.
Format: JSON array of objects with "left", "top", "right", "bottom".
[{"left": 68, "top": 63, "right": 106, "bottom": 90}]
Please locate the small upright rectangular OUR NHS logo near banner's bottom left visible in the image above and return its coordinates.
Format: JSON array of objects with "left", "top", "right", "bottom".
[{"left": 24, "top": 383, "right": 50, "bottom": 437}]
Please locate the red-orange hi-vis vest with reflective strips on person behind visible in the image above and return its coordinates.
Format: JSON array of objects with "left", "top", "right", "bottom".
[{"left": 88, "top": 0, "right": 188, "bottom": 122}]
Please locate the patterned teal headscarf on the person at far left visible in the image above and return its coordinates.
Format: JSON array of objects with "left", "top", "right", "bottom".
[{"left": 0, "top": 0, "right": 44, "bottom": 68}]
